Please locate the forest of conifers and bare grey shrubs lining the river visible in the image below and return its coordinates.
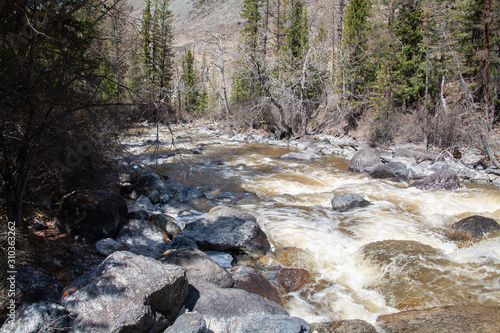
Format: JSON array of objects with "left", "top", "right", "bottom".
[{"left": 0, "top": 0, "right": 500, "bottom": 227}]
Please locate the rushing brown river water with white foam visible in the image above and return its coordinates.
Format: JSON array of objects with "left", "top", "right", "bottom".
[{"left": 125, "top": 124, "right": 500, "bottom": 323}]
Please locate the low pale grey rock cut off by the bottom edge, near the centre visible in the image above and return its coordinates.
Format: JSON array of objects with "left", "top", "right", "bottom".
[{"left": 229, "top": 314, "right": 310, "bottom": 333}]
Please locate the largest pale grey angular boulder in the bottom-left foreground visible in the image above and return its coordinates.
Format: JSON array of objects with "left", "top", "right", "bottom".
[{"left": 61, "top": 251, "right": 188, "bottom": 332}]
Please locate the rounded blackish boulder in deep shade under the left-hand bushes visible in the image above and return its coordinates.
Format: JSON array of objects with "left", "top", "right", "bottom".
[{"left": 56, "top": 190, "right": 128, "bottom": 243}]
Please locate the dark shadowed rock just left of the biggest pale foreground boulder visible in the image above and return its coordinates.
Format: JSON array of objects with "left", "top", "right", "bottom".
[{"left": 16, "top": 267, "right": 64, "bottom": 304}]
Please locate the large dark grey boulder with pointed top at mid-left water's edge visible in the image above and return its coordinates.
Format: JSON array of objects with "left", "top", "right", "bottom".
[{"left": 178, "top": 215, "right": 271, "bottom": 256}]
